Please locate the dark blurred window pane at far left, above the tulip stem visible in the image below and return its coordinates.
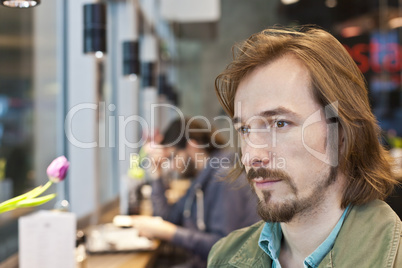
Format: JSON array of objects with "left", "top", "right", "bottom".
[{"left": 0, "top": 5, "right": 34, "bottom": 201}]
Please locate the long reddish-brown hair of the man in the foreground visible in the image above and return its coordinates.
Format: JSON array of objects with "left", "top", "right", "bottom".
[{"left": 215, "top": 26, "right": 398, "bottom": 207}]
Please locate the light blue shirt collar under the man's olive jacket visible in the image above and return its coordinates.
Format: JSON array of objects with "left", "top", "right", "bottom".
[{"left": 258, "top": 206, "right": 349, "bottom": 268}]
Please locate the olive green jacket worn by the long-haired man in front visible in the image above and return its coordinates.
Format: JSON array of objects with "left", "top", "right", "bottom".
[{"left": 208, "top": 200, "right": 402, "bottom": 268}]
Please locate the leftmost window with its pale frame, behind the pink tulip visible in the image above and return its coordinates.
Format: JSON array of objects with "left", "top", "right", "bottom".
[{"left": 0, "top": 1, "right": 62, "bottom": 262}]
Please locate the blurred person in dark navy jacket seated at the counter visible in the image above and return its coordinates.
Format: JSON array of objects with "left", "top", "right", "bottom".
[{"left": 132, "top": 118, "right": 259, "bottom": 267}]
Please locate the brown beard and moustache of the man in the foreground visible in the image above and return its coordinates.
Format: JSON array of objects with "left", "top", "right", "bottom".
[{"left": 247, "top": 167, "right": 337, "bottom": 222}]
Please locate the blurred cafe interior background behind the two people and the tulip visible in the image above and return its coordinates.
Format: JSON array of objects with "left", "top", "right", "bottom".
[{"left": 0, "top": 0, "right": 402, "bottom": 268}]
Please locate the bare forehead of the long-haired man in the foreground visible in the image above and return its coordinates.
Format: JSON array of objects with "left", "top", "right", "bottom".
[{"left": 232, "top": 56, "right": 320, "bottom": 123}]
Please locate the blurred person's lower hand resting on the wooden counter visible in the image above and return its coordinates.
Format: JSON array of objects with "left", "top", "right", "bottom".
[{"left": 131, "top": 216, "right": 177, "bottom": 241}]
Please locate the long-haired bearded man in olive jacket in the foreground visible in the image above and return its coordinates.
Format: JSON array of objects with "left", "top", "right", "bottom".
[{"left": 208, "top": 27, "right": 402, "bottom": 268}]
